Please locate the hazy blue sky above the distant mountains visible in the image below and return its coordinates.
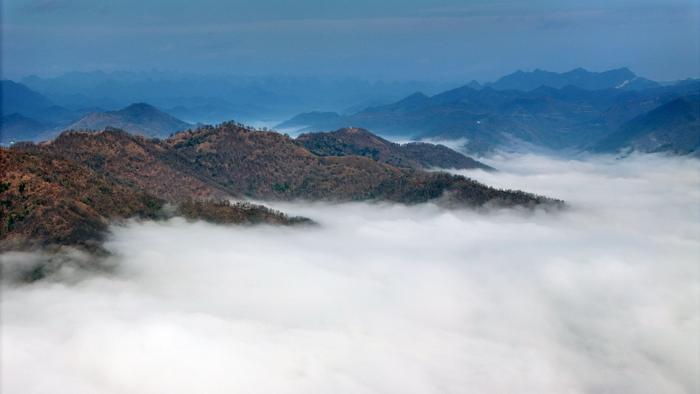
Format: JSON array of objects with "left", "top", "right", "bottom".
[{"left": 2, "top": 0, "right": 700, "bottom": 81}]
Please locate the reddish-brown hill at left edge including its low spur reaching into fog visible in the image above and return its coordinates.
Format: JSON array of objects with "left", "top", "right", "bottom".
[{"left": 0, "top": 148, "right": 310, "bottom": 252}]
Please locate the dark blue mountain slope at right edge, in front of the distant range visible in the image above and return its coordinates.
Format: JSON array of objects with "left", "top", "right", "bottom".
[{"left": 594, "top": 95, "right": 700, "bottom": 154}]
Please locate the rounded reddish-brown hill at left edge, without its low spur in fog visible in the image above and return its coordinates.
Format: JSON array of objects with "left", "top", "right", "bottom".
[{"left": 0, "top": 148, "right": 162, "bottom": 249}]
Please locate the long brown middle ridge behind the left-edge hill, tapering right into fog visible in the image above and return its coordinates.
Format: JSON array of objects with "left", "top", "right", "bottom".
[{"left": 17, "top": 123, "right": 551, "bottom": 206}]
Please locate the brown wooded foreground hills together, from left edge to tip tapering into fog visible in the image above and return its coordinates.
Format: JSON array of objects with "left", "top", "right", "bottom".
[{"left": 0, "top": 123, "right": 561, "bottom": 248}]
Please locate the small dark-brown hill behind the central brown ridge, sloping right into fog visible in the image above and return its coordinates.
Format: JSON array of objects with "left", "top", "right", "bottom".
[{"left": 296, "top": 128, "right": 493, "bottom": 170}]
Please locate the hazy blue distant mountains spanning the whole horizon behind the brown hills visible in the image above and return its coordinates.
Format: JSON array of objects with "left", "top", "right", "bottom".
[{"left": 5, "top": 68, "right": 700, "bottom": 154}]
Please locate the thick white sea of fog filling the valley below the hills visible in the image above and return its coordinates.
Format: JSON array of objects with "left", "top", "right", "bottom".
[{"left": 1, "top": 152, "right": 700, "bottom": 394}]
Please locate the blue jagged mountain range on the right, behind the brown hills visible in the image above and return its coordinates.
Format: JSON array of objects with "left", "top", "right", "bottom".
[{"left": 278, "top": 69, "right": 700, "bottom": 153}]
